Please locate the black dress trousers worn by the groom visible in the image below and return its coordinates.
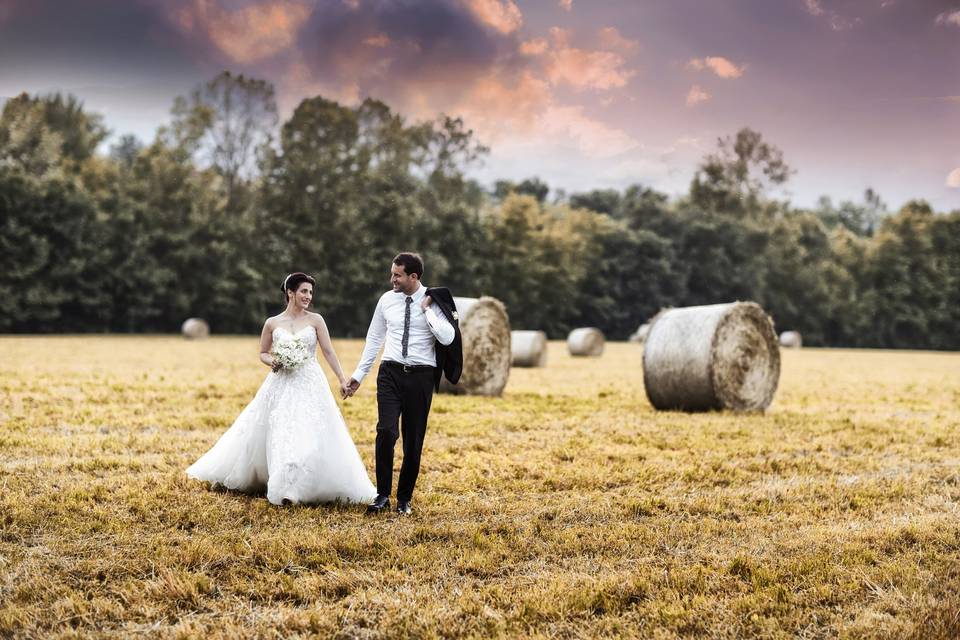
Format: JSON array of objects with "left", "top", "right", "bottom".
[{"left": 376, "top": 361, "right": 434, "bottom": 502}]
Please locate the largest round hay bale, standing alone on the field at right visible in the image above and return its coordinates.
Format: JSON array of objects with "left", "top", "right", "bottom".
[{"left": 643, "top": 302, "right": 780, "bottom": 411}]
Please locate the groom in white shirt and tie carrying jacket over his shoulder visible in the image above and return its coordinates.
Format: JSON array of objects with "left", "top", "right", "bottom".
[{"left": 348, "top": 253, "right": 463, "bottom": 515}]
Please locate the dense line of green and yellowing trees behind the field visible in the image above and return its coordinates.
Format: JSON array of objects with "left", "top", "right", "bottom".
[{"left": 0, "top": 73, "right": 960, "bottom": 349}]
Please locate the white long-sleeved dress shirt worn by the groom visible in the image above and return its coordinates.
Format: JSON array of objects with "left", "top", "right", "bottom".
[{"left": 353, "top": 283, "right": 456, "bottom": 382}]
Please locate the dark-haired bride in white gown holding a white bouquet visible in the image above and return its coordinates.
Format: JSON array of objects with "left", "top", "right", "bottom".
[{"left": 187, "top": 272, "right": 377, "bottom": 504}]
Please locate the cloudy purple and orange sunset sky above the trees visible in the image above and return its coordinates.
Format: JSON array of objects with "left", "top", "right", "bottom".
[{"left": 0, "top": 0, "right": 960, "bottom": 211}]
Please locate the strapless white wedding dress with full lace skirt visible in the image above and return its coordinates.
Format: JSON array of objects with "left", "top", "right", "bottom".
[{"left": 187, "top": 326, "right": 377, "bottom": 504}]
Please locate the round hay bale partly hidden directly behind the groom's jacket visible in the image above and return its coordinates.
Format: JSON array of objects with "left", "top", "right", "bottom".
[{"left": 440, "top": 296, "right": 511, "bottom": 396}]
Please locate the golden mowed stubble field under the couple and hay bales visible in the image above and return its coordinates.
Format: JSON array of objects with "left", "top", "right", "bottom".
[{"left": 0, "top": 337, "right": 960, "bottom": 638}]
